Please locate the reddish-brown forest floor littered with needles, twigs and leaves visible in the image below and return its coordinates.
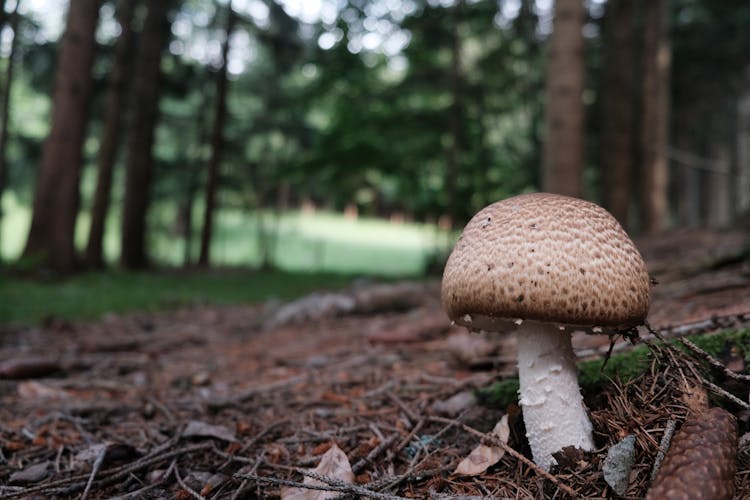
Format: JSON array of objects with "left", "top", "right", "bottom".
[{"left": 0, "top": 232, "right": 750, "bottom": 500}]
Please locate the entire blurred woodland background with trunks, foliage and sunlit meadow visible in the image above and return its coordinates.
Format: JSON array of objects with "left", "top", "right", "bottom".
[{"left": 0, "top": 0, "right": 750, "bottom": 282}]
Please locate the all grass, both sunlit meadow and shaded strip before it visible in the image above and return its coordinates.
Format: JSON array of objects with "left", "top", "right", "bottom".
[{"left": 0, "top": 192, "right": 452, "bottom": 325}]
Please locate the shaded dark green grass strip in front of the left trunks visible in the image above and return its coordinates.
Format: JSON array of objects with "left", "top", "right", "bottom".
[{"left": 0, "top": 270, "right": 358, "bottom": 325}]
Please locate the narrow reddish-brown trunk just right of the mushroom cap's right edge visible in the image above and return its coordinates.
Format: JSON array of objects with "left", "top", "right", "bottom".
[{"left": 640, "top": 0, "right": 672, "bottom": 234}]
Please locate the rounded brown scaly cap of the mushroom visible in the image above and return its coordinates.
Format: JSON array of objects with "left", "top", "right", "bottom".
[{"left": 442, "top": 193, "right": 651, "bottom": 329}]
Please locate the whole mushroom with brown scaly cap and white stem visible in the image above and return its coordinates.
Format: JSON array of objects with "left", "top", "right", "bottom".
[{"left": 442, "top": 193, "right": 650, "bottom": 470}]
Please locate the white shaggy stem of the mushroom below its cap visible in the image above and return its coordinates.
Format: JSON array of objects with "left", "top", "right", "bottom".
[{"left": 516, "top": 321, "right": 594, "bottom": 470}]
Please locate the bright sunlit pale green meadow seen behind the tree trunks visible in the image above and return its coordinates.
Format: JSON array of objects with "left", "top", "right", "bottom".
[{"left": 0, "top": 192, "right": 453, "bottom": 276}]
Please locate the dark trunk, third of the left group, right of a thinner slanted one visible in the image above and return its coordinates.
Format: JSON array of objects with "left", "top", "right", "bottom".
[{"left": 120, "top": 1, "right": 170, "bottom": 269}]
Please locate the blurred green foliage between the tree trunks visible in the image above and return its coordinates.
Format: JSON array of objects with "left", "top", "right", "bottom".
[{"left": 4, "top": 0, "right": 750, "bottom": 270}]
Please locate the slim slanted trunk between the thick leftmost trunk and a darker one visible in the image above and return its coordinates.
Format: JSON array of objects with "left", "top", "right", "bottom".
[{"left": 86, "top": 0, "right": 137, "bottom": 268}]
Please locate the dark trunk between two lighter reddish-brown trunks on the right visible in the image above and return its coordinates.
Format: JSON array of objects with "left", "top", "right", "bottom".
[{"left": 600, "top": 0, "right": 635, "bottom": 228}]
